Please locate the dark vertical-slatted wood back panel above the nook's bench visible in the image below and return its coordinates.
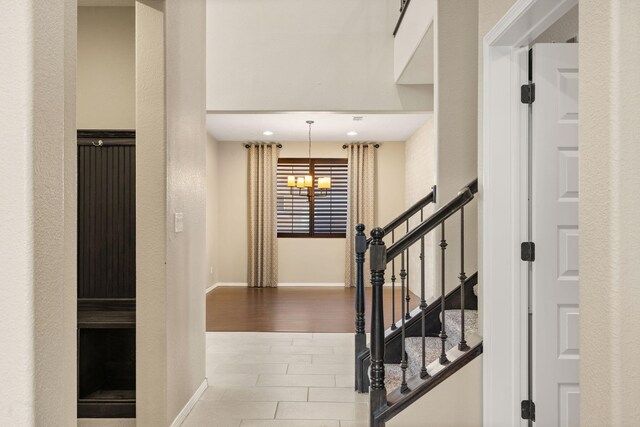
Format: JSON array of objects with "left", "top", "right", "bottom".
[{"left": 78, "top": 140, "right": 136, "bottom": 298}]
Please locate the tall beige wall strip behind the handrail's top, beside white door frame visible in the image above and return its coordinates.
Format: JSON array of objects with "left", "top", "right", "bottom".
[{"left": 434, "top": 0, "right": 478, "bottom": 296}]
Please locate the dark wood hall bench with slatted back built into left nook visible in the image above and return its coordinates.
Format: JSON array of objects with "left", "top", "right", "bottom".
[{"left": 78, "top": 130, "right": 136, "bottom": 418}]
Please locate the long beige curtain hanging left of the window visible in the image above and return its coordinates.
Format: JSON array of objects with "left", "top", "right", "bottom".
[{"left": 247, "top": 144, "right": 279, "bottom": 288}]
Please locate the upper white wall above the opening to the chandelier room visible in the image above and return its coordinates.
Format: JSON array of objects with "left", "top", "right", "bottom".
[{"left": 207, "top": 0, "right": 433, "bottom": 111}]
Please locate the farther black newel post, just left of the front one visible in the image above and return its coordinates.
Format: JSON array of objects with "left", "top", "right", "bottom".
[{"left": 355, "top": 224, "right": 367, "bottom": 393}]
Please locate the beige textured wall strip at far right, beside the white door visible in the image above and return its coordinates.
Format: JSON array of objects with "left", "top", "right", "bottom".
[{"left": 580, "top": 0, "right": 640, "bottom": 427}]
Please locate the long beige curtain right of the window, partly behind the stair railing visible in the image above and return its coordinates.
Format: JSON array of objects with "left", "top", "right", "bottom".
[{"left": 344, "top": 144, "right": 376, "bottom": 287}]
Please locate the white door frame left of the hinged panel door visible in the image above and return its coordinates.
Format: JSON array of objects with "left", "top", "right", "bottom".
[{"left": 480, "top": 0, "right": 578, "bottom": 427}]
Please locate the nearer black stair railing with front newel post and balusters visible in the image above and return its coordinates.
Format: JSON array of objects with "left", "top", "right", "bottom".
[{"left": 369, "top": 180, "right": 477, "bottom": 426}]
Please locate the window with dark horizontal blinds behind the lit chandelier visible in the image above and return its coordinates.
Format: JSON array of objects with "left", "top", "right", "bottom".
[{"left": 277, "top": 158, "right": 347, "bottom": 237}]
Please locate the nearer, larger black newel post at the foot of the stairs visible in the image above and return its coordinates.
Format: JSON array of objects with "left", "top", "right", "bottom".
[{"left": 369, "top": 227, "right": 387, "bottom": 426}]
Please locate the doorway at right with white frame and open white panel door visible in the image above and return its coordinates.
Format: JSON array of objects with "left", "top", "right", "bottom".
[{"left": 481, "top": 0, "right": 579, "bottom": 425}]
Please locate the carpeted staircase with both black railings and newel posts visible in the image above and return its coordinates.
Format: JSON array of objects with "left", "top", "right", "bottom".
[{"left": 355, "top": 180, "right": 482, "bottom": 427}]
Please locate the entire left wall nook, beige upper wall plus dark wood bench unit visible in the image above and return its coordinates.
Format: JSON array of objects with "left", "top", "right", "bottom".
[{"left": 77, "top": 1, "right": 136, "bottom": 419}]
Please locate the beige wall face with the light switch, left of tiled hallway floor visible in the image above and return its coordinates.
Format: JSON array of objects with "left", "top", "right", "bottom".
[{"left": 165, "top": 0, "right": 207, "bottom": 421}]
